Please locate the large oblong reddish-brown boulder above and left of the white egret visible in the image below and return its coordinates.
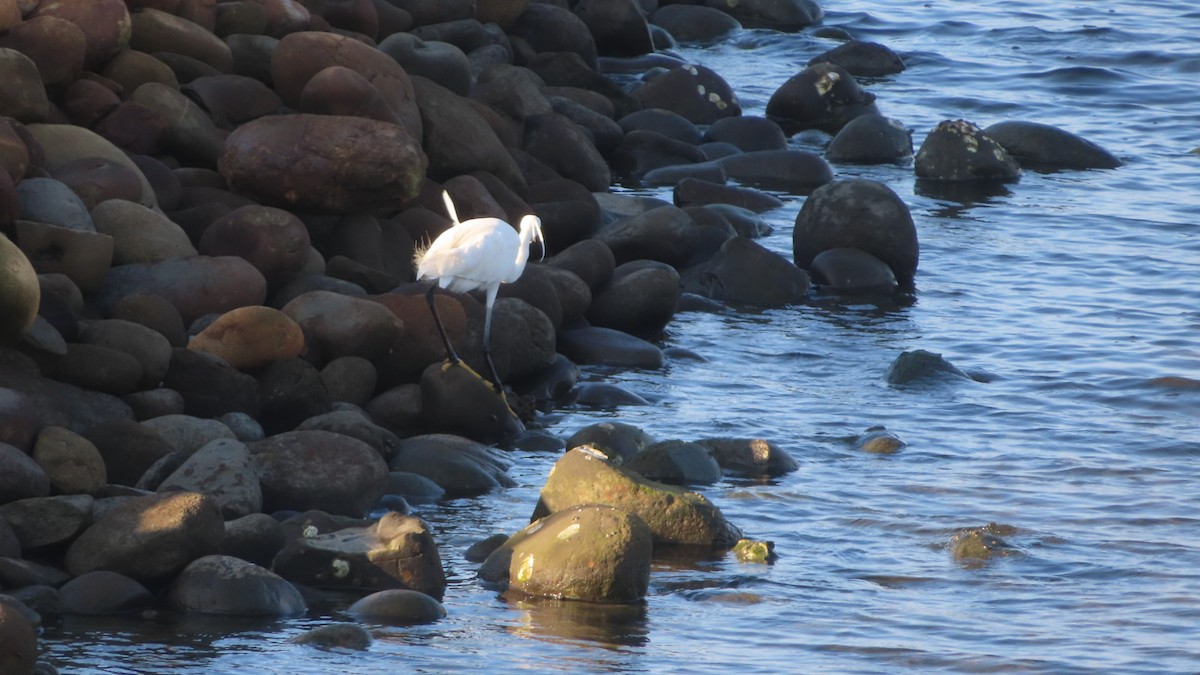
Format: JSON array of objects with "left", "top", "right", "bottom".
[{"left": 218, "top": 115, "right": 427, "bottom": 214}]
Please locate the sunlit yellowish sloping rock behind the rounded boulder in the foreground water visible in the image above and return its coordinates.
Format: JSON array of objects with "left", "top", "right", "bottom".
[{"left": 533, "top": 448, "right": 742, "bottom": 549}]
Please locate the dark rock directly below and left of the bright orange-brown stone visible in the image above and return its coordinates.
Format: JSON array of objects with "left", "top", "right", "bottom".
[{"left": 162, "top": 348, "right": 262, "bottom": 417}]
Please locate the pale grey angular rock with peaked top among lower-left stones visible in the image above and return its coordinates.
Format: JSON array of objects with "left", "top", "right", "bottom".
[{"left": 157, "top": 438, "right": 263, "bottom": 520}]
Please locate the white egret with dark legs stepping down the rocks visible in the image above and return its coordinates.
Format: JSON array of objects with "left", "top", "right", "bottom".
[{"left": 415, "top": 191, "right": 546, "bottom": 399}]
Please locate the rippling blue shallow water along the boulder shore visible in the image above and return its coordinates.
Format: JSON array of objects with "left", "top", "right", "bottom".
[{"left": 42, "top": 0, "right": 1200, "bottom": 674}]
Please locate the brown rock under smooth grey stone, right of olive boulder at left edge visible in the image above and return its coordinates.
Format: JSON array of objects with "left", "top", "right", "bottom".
[{"left": 14, "top": 220, "right": 113, "bottom": 293}]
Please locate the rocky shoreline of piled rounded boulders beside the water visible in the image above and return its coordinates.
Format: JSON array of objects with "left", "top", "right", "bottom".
[{"left": 0, "top": 0, "right": 1118, "bottom": 673}]
